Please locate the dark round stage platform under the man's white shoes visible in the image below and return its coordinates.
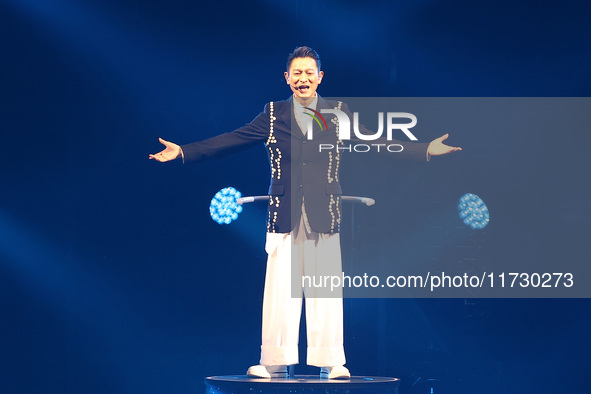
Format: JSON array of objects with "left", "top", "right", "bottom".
[{"left": 205, "top": 375, "right": 400, "bottom": 394}]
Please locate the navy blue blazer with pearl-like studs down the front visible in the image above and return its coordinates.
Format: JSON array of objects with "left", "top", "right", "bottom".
[{"left": 181, "top": 96, "right": 428, "bottom": 234}]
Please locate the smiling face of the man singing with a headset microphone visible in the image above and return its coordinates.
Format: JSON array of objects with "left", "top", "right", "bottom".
[{"left": 284, "top": 57, "right": 324, "bottom": 101}]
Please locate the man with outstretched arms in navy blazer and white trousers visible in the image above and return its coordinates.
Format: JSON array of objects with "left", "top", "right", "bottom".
[{"left": 150, "top": 47, "right": 461, "bottom": 379}]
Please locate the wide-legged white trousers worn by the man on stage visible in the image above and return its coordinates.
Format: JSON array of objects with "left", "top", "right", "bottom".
[{"left": 260, "top": 226, "right": 345, "bottom": 367}]
